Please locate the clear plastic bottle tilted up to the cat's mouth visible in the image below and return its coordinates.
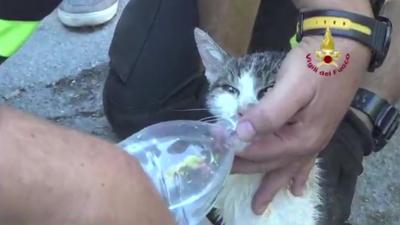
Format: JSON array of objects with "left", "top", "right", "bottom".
[{"left": 119, "top": 121, "right": 238, "bottom": 225}]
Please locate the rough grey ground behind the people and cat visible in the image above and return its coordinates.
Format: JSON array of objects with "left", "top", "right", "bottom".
[{"left": 0, "top": 0, "right": 400, "bottom": 225}]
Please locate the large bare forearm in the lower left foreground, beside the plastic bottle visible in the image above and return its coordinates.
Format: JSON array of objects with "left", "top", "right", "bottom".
[{"left": 0, "top": 106, "right": 173, "bottom": 225}]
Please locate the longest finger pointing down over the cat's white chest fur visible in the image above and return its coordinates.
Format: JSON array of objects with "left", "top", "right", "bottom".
[{"left": 252, "top": 169, "right": 291, "bottom": 215}]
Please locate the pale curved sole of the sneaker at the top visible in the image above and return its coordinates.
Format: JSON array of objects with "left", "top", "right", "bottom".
[{"left": 57, "top": 1, "right": 118, "bottom": 27}]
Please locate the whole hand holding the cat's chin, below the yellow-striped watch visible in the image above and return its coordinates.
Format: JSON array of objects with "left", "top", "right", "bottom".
[{"left": 233, "top": 33, "right": 370, "bottom": 214}]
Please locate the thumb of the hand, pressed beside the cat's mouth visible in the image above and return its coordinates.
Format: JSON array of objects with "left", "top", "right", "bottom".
[{"left": 236, "top": 69, "right": 314, "bottom": 141}]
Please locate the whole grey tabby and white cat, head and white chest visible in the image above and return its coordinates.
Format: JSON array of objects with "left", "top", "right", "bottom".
[{"left": 194, "top": 28, "right": 320, "bottom": 225}]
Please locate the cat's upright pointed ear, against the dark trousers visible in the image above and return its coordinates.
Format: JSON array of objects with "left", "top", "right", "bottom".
[{"left": 194, "top": 28, "right": 230, "bottom": 83}]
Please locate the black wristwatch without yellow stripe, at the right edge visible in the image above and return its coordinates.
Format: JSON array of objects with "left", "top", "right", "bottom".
[{"left": 351, "top": 88, "right": 400, "bottom": 152}]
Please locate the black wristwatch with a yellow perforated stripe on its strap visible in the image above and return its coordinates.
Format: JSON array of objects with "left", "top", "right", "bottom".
[{"left": 296, "top": 9, "right": 392, "bottom": 72}]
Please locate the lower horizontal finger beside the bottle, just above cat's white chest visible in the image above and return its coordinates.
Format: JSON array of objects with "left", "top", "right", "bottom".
[{"left": 232, "top": 157, "right": 286, "bottom": 174}]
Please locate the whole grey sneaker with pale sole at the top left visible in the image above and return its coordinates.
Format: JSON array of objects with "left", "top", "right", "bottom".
[{"left": 57, "top": 0, "right": 118, "bottom": 27}]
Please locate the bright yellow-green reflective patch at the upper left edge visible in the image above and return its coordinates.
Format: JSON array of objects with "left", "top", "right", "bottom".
[{"left": 0, "top": 19, "right": 39, "bottom": 57}]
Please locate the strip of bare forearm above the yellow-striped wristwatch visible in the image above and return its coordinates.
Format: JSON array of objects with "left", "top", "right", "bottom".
[{"left": 293, "top": 0, "right": 373, "bottom": 17}]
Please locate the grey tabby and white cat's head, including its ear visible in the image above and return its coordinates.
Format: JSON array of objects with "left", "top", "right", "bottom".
[{"left": 195, "top": 29, "right": 284, "bottom": 123}]
